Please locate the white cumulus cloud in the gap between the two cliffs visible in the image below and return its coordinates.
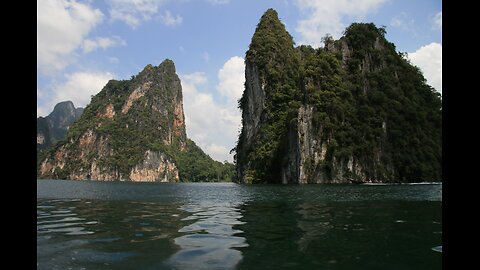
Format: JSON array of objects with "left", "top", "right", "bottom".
[{"left": 180, "top": 56, "right": 245, "bottom": 162}]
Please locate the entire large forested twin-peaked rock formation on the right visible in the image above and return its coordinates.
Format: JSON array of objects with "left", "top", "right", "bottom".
[{"left": 236, "top": 9, "right": 442, "bottom": 183}]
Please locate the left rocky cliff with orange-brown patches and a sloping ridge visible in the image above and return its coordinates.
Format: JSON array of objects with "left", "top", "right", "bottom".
[{"left": 38, "top": 59, "right": 187, "bottom": 182}]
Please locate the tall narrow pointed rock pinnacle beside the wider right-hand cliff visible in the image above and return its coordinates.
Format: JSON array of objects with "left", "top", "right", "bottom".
[{"left": 236, "top": 9, "right": 300, "bottom": 182}]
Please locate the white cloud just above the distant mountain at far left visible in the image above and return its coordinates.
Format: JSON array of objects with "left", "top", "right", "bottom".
[{"left": 37, "top": 72, "right": 113, "bottom": 116}]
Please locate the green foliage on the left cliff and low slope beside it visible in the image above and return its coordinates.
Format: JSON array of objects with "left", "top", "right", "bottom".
[{"left": 40, "top": 60, "right": 234, "bottom": 182}]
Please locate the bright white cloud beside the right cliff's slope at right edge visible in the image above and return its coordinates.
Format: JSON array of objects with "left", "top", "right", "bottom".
[{"left": 408, "top": 42, "right": 442, "bottom": 93}]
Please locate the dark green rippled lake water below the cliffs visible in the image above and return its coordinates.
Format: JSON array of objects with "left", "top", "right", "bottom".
[{"left": 37, "top": 180, "right": 442, "bottom": 270}]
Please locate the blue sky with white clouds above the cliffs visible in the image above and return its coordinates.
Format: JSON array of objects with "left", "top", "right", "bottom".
[{"left": 37, "top": 0, "right": 442, "bottom": 162}]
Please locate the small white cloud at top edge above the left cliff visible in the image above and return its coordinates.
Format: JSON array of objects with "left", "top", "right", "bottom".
[{"left": 108, "top": 0, "right": 168, "bottom": 29}]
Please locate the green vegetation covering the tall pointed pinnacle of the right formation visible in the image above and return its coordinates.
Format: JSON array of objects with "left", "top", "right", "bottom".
[{"left": 237, "top": 9, "right": 301, "bottom": 181}]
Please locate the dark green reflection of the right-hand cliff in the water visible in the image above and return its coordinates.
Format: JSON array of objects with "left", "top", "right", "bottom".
[{"left": 236, "top": 201, "right": 441, "bottom": 269}]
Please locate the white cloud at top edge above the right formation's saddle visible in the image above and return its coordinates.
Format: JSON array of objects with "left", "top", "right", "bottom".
[{"left": 295, "top": 0, "right": 386, "bottom": 47}]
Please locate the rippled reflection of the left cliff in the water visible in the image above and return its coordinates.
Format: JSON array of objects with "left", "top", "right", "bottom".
[{"left": 37, "top": 200, "right": 187, "bottom": 269}]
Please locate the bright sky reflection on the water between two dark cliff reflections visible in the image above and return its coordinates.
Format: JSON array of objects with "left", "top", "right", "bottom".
[{"left": 167, "top": 202, "right": 248, "bottom": 269}]
